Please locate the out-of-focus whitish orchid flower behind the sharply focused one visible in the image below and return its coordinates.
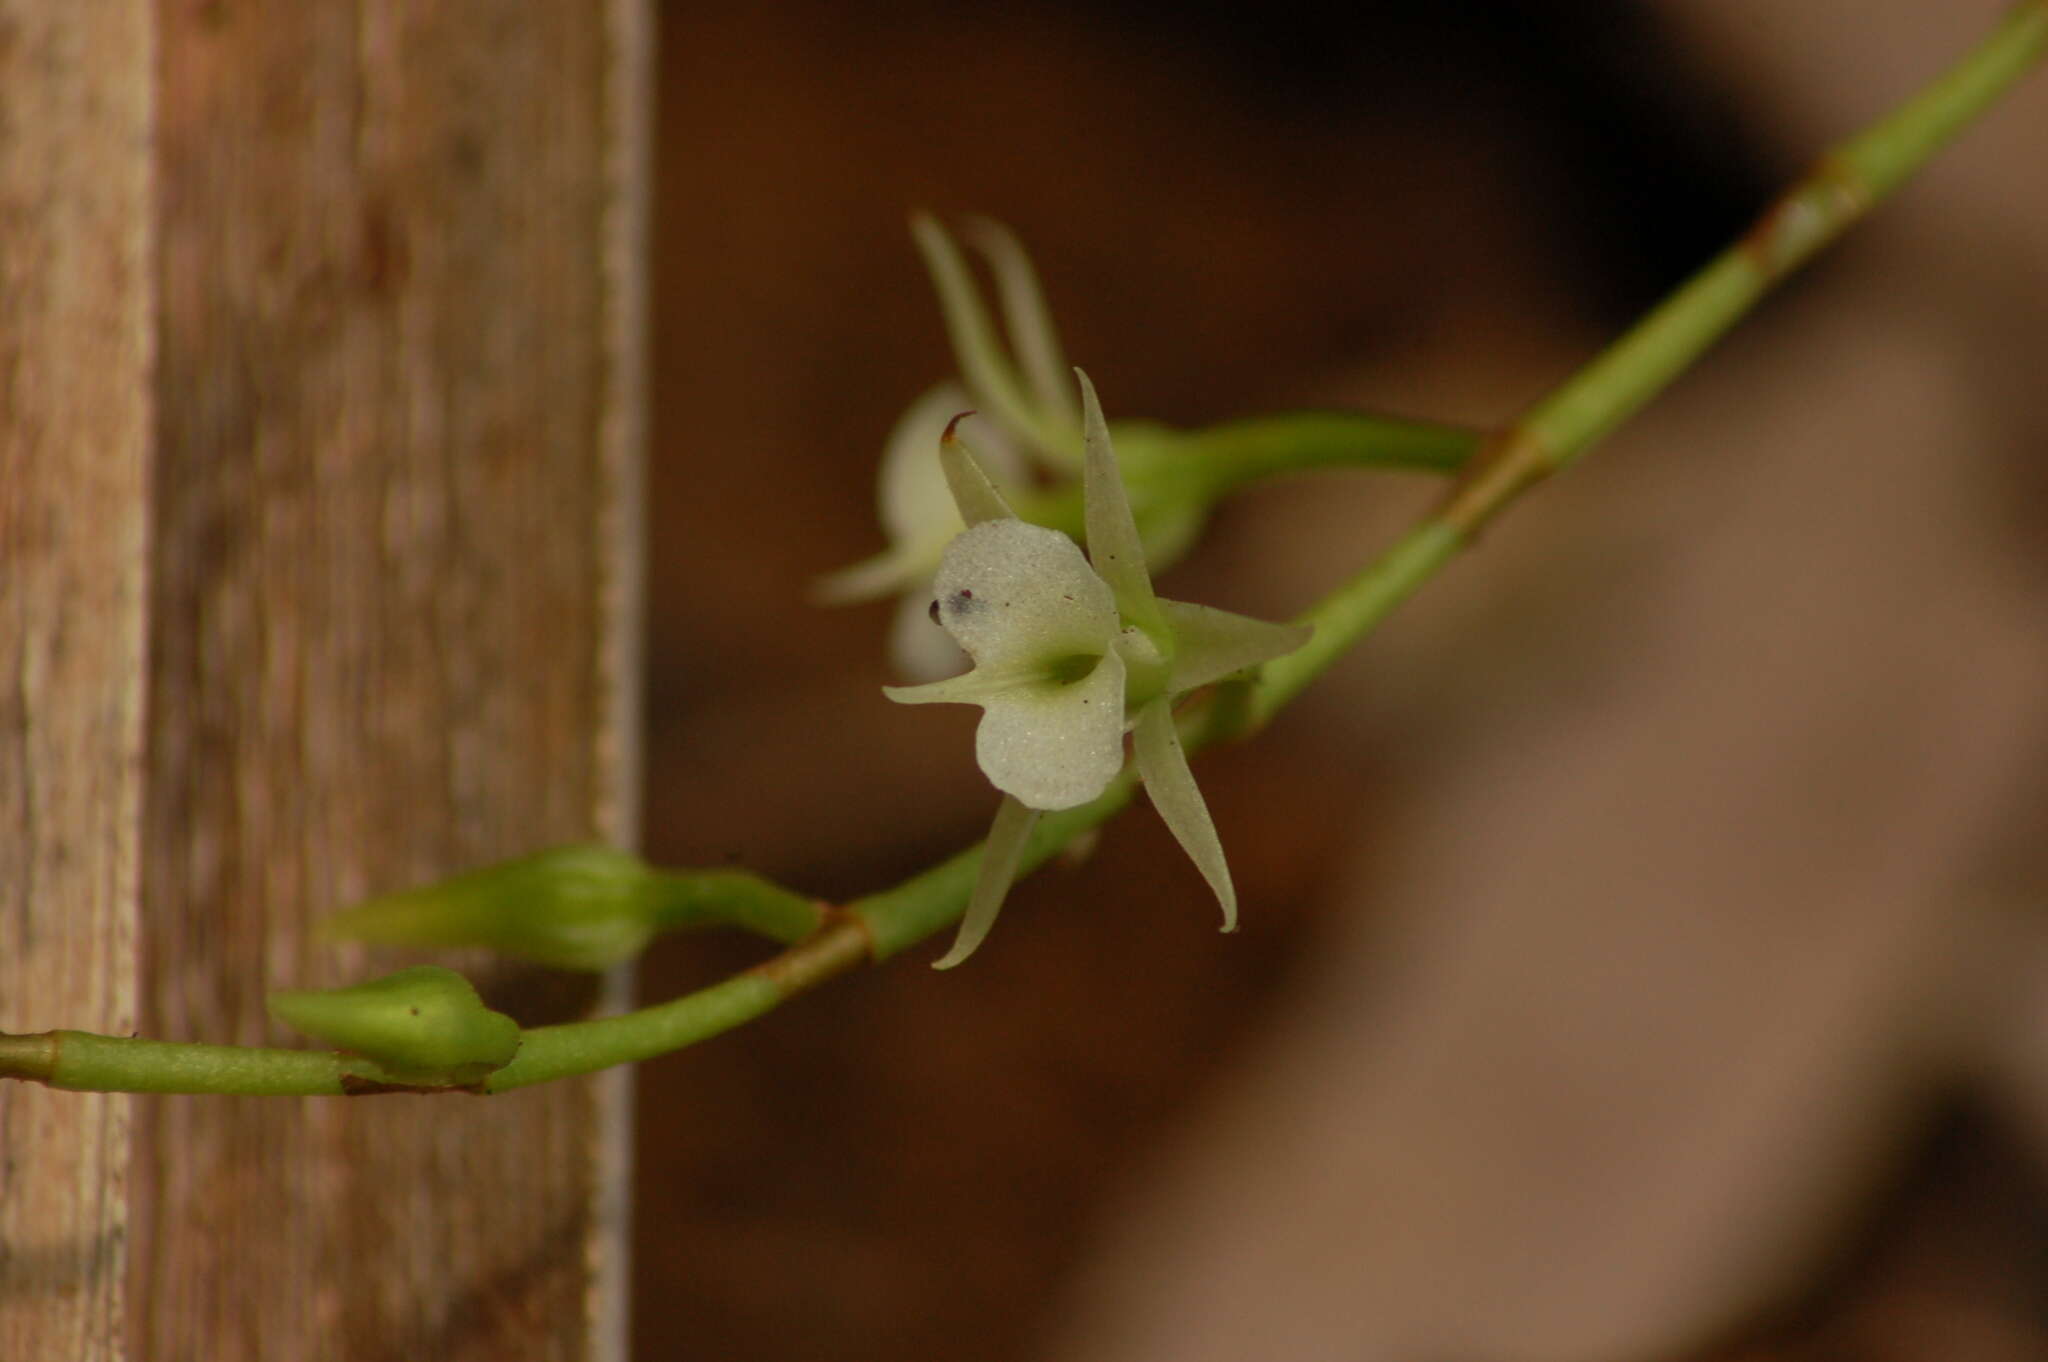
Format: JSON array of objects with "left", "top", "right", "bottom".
[{"left": 817, "top": 213, "right": 1200, "bottom": 680}]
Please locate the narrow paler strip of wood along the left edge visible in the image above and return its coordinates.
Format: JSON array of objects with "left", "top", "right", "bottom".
[{"left": 0, "top": 0, "right": 152, "bottom": 1362}]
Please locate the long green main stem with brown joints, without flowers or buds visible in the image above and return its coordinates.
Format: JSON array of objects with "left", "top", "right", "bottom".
[{"left": 0, "top": 0, "right": 2048, "bottom": 1094}]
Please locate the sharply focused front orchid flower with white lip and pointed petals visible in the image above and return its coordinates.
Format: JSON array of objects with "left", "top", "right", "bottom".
[{"left": 883, "top": 371, "right": 1309, "bottom": 969}]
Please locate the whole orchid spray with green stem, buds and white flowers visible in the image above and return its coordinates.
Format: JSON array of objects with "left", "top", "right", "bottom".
[{"left": 0, "top": 0, "right": 2048, "bottom": 1096}]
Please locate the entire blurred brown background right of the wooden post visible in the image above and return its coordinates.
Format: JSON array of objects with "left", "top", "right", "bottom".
[{"left": 635, "top": 2, "right": 2048, "bottom": 1362}]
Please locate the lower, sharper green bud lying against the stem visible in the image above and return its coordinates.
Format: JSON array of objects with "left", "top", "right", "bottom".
[{"left": 268, "top": 965, "right": 518, "bottom": 1083}]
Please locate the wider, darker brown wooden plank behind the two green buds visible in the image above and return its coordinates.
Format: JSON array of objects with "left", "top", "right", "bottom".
[{"left": 129, "top": 0, "right": 639, "bottom": 1362}]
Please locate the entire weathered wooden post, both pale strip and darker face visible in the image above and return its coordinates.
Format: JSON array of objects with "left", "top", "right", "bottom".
[{"left": 0, "top": 0, "right": 647, "bottom": 1362}]
